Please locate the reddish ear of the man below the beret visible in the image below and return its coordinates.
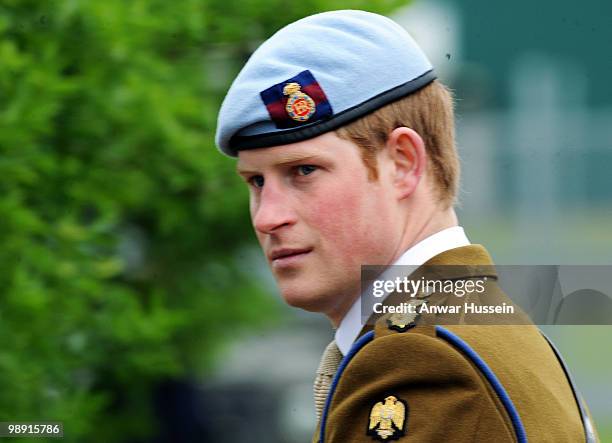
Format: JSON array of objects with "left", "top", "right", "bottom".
[{"left": 387, "top": 126, "right": 427, "bottom": 199}]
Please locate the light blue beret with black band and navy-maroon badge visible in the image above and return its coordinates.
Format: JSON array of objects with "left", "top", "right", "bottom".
[{"left": 216, "top": 10, "right": 435, "bottom": 157}]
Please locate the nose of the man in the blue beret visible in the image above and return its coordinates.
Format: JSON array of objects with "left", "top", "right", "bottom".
[{"left": 253, "top": 186, "right": 296, "bottom": 234}]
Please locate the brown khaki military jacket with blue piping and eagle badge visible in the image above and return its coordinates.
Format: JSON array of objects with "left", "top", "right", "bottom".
[{"left": 313, "top": 245, "right": 599, "bottom": 443}]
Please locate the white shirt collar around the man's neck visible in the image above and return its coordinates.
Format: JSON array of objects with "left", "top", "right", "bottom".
[{"left": 335, "top": 226, "right": 470, "bottom": 355}]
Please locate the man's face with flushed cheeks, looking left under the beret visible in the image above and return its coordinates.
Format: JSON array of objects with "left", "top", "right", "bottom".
[{"left": 238, "top": 132, "right": 402, "bottom": 317}]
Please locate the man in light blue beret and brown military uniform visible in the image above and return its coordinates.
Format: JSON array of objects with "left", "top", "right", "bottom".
[{"left": 216, "top": 11, "right": 595, "bottom": 443}]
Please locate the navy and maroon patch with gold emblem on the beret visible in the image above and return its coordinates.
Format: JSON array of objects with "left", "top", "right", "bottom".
[{"left": 260, "top": 71, "right": 333, "bottom": 129}]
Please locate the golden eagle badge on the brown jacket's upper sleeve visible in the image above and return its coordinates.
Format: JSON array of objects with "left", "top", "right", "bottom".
[{"left": 367, "top": 395, "right": 408, "bottom": 441}]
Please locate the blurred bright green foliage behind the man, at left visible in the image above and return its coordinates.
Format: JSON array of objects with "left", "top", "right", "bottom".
[{"left": 0, "top": 0, "right": 405, "bottom": 442}]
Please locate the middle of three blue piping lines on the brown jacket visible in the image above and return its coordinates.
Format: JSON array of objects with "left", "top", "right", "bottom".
[{"left": 436, "top": 326, "right": 527, "bottom": 443}]
